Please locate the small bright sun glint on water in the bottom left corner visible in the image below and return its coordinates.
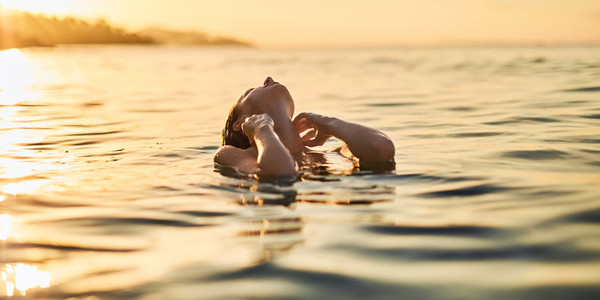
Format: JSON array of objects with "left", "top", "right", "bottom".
[{"left": 0, "top": 263, "right": 50, "bottom": 297}]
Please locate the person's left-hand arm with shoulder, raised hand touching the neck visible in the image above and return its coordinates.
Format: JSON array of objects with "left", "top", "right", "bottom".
[{"left": 214, "top": 114, "right": 298, "bottom": 176}]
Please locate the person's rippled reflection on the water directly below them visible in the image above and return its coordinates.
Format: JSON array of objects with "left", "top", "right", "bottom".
[{"left": 221, "top": 174, "right": 396, "bottom": 263}]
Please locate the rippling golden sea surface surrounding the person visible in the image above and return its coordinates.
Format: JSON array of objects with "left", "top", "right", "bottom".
[{"left": 0, "top": 46, "right": 600, "bottom": 300}]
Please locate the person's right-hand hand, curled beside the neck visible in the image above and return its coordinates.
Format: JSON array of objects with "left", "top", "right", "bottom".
[{"left": 293, "top": 112, "right": 333, "bottom": 147}]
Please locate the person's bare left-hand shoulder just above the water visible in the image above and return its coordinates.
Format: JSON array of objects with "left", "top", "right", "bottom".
[{"left": 214, "top": 145, "right": 258, "bottom": 174}]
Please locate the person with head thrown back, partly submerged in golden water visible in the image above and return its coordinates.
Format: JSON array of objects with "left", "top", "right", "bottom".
[{"left": 214, "top": 77, "right": 395, "bottom": 177}]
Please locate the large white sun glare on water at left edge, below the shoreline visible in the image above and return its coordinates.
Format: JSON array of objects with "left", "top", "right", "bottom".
[{"left": 0, "top": 49, "right": 70, "bottom": 200}]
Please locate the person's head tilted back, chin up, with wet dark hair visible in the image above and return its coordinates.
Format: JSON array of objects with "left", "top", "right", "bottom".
[{"left": 221, "top": 77, "right": 294, "bottom": 149}]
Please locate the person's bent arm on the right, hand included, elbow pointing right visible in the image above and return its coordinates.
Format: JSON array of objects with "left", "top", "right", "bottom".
[{"left": 294, "top": 113, "right": 395, "bottom": 163}]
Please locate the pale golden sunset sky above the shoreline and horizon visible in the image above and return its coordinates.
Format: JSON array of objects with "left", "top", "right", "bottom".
[{"left": 0, "top": 0, "right": 600, "bottom": 47}]
